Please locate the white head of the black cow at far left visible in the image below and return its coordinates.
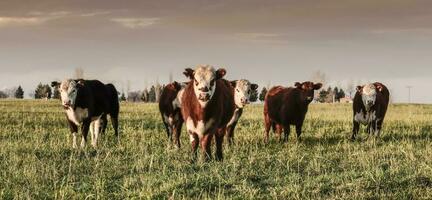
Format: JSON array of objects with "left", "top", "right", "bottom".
[{"left": 51, "top": 79, "right": 84, "bottom": 109}]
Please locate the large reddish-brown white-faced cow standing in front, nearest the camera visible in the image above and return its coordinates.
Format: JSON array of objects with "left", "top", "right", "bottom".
[{"left": 181, "top": 65, "right": 235, "bottom": 162}]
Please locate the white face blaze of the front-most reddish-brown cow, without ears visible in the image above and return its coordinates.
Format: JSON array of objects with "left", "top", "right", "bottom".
[{"left": 193, "top": 65, "right": 216, "bottom": 107}]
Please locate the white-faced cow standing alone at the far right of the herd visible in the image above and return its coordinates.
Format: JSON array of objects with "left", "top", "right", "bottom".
[{"left": 351, "top": 82, "right": 390, "bottom": 140}]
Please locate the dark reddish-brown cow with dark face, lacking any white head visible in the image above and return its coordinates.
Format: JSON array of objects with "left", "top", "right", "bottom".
[{"left": 264, "top": 81, "right": 322, "bottom": 142}]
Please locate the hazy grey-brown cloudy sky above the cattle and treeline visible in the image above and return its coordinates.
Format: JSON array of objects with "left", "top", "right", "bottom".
[{"left": 0, "top": 0, "right": 432, "bottom": 103}]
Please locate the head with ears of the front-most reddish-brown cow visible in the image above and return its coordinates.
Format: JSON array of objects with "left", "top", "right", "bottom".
[{"left": 183, "top": 65, "right": 226, "bottom": 107}]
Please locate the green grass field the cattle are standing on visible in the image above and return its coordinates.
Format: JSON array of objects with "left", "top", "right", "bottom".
[{"left": 0, "top": 100, "right": 432, "bottom": 199}]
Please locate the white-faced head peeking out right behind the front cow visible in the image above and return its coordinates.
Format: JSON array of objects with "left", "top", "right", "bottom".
[{"left": 231, "top": 79, "right": 258, "bottom": 108}]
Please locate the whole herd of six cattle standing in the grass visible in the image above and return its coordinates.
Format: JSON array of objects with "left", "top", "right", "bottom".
[{"left": 51, "top": 65, "right": 390, "bottom": 160}]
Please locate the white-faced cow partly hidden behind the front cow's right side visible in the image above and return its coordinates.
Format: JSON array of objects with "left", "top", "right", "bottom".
[{"left": 225, "top": 79, "right": 258, "bottom": 144}]
